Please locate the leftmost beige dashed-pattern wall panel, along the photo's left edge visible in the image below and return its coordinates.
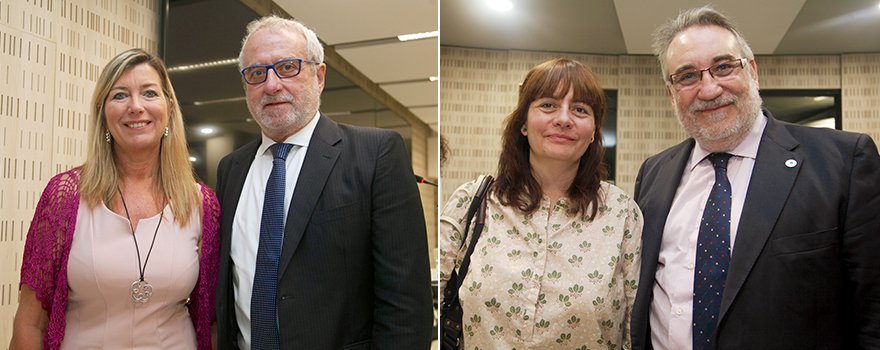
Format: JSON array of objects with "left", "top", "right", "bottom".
[{"left": 0, "top": 8, "right": 55, "bottom": 336}]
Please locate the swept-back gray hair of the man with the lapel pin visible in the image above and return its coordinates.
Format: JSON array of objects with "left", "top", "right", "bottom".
[{"left": 653, "top": 5, "right": 755, "bottom": 81}]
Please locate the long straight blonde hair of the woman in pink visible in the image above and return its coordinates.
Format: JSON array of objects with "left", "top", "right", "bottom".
[{"left": 79, "top": 49, "right": 201, "bottom": 226}]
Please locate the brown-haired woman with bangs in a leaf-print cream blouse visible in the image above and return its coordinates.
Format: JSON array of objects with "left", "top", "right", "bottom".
[{"left": 440, "top": 59, "right": 642, "bottom": 349}]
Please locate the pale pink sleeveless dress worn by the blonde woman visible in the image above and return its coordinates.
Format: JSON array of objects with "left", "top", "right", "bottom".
[{"left": 61, "top": 202, "right": 202, "bottom": 349}]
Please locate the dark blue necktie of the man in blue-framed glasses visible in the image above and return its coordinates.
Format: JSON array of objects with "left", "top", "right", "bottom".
[{"left": 251, "top": 143, "right": 293, "bottom": 350}]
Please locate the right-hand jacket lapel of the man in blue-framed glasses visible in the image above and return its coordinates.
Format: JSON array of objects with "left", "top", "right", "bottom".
[{"left": 278, "top": 113, "right": 342, "bottom": 278}]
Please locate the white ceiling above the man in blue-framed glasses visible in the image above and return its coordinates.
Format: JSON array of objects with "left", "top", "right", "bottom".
[{"left": 275, "top": 0, "right": 439, "bottom": 131}]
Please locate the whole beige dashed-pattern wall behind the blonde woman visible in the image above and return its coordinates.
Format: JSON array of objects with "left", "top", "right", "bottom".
[{"left": 0, "top": 0, "right": 159, "bottom": 349}]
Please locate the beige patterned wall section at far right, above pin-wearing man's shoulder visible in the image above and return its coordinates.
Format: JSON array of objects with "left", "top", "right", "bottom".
[{"left": 841, "top": 53, "right": 880, "bottom": 142}]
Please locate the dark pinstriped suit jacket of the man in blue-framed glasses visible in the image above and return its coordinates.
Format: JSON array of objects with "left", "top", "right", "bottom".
[{"left": 217, "top": 114, "right": 433, "bottom": 350}]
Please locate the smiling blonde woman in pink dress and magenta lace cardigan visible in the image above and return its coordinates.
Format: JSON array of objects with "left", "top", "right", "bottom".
[{"left": 10, "top": 49, "right": 219, "bottom": 349}]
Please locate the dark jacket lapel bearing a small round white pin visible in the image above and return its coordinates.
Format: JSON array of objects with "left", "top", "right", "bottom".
[{"left": 719, "top": 110, "right": 804, "bottom": 329}]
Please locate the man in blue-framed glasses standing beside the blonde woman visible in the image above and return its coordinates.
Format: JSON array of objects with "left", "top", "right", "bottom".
[{"left": 217, "top": 16, "right": 433, "bottom": 350}]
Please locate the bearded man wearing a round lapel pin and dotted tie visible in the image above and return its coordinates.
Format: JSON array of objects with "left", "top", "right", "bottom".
[{"left": 632, "top": 7, "right": 880, "bottom": 350}]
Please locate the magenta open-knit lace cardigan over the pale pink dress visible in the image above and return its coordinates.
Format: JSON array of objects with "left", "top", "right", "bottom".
[{"left": 21, "top": 168, "right": 220, "bottom": 350}]
